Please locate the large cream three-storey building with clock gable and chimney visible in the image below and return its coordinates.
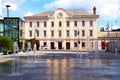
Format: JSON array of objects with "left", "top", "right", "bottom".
[{"left": 24, "top": 7, "right": 99, "bottom": 50}]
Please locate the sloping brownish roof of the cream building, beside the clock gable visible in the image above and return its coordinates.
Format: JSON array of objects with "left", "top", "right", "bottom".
[{"left": 24, "top": 8, "right": 98, "bottom": 18}]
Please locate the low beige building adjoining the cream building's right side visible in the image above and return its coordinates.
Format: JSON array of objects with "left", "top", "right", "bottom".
[{"left": 98, "top": 30, "right": 120, "bottom": 52}]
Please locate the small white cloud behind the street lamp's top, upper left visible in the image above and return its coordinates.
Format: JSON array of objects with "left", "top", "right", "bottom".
[{"left": 3, "top": 0, "right": 26, "bottom": 11}]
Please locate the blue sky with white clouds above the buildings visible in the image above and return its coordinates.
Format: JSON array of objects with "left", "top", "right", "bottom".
[{"left": 2, "top": 0, "right": 120, "bottom": 30}]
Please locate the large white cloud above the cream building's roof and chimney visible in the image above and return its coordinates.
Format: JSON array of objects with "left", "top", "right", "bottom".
[{"left": 44, "top": 0, "right": 120, "bottom": 19}]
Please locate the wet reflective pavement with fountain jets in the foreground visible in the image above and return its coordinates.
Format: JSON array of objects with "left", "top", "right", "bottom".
[{"left": 0, "top": 53, "right": 120, "bottom": 80}]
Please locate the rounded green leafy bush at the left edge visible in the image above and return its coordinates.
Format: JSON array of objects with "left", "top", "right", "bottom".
[{"left": 0, "top": 36, "right": 13, "bottom": 51}]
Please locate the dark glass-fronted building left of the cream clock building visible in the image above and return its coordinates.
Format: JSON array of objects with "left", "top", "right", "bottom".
[{"left": 0, "top": 17, "right": 25, "bottom": 49}]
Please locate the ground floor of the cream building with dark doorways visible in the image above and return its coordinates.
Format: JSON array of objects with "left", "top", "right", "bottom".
[{"left": 39, "top": 39, "right": 95, "bottom": 50}]
